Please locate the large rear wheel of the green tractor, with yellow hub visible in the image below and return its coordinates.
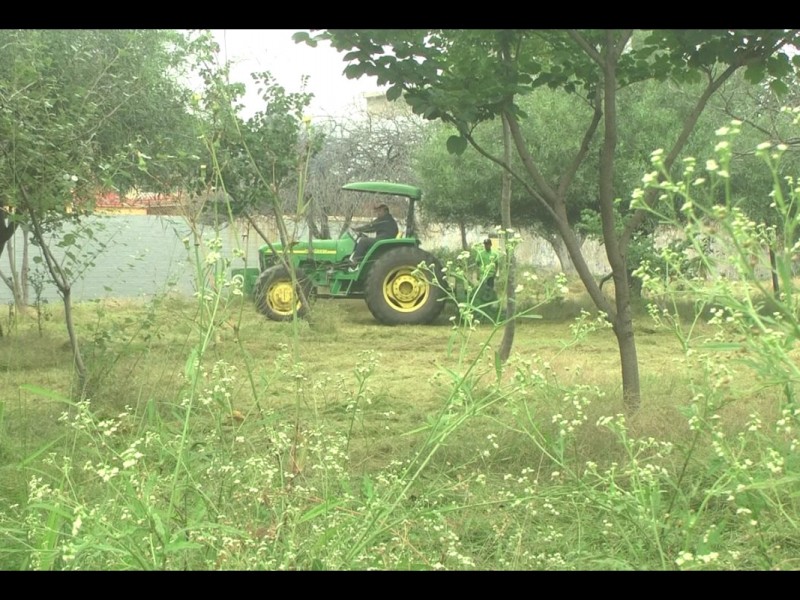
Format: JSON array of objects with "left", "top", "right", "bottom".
[{"left": 364, "top": 247, "right": 445, "bottom": 325}]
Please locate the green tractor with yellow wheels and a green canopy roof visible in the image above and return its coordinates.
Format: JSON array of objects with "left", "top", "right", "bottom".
[{"left": 253, "top": 181, "right": 447, "bottom": 325}]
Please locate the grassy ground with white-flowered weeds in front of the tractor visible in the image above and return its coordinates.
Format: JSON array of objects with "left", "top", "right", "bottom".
[{"left": 0, "top": 285, "right": 798, "bottom": 570}]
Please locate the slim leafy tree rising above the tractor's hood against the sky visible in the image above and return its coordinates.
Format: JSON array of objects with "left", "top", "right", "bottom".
[{"left": 191, "top": 36, "right": 321, "bottom": 253}]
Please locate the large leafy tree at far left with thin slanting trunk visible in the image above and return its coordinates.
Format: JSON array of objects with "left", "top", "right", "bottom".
[{"left": 0, "top": 30, "right": 203, "bottom": 392}]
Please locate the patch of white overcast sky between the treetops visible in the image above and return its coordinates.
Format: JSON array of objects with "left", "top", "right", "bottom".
[{"left": 212, "top": 29, "right": 378, "bottom": 118}]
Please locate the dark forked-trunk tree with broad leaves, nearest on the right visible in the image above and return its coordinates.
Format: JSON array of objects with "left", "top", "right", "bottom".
[{"left": 295, "top": 30, "right": 797, "bottom": 410}]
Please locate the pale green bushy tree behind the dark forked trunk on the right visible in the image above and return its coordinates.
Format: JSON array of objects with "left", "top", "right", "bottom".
[{"left": 416, "top": 77, "right": 718, "bottom": 273}]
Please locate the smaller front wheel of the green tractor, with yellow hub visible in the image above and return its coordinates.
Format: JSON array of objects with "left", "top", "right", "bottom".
[{"left": 254, "top": 265, "right": 312, "bottom": 321}]
